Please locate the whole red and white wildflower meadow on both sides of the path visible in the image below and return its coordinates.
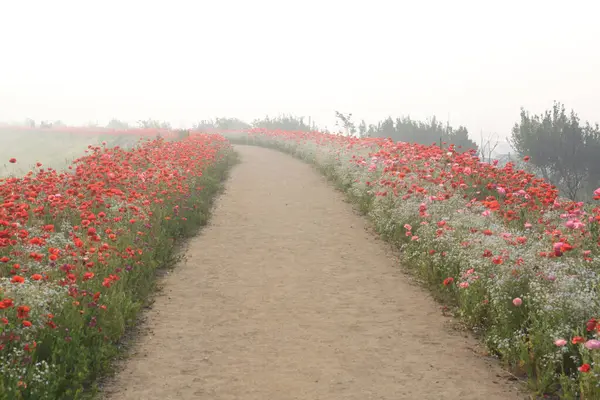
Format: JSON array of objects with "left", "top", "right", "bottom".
[{"left": 0, "top": 129, "right": 600, "bottom": 400}]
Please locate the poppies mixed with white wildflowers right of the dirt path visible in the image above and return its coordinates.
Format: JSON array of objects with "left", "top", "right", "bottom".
[{"left": 227, "top": 129, "right": 600, "bottom": 399}]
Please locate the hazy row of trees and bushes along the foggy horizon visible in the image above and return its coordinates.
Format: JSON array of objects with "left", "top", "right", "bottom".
[{"left": 22, "top": 102, "right": 600, "bottom": 200}]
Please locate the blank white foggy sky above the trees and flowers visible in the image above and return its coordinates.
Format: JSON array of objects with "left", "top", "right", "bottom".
[{"left": 0, "top": 0, "right": 600, "bottom": 144}]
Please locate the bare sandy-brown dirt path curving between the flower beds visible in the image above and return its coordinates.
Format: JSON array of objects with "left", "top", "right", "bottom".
[{"left": 105, "top": 146, "right": 520, "bottom": 400}]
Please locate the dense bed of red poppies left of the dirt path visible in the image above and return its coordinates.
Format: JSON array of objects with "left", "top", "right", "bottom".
[{"left": 0, "top": 134, "right": 235, "bottom": 400}]
